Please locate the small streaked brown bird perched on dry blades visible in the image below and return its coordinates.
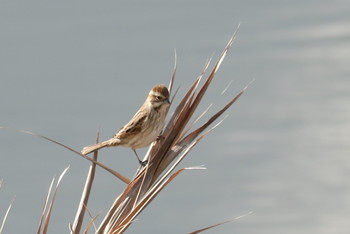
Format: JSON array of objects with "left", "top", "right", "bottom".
[{"left": 81, "top": 85, "right": 170, "bottom": 165}]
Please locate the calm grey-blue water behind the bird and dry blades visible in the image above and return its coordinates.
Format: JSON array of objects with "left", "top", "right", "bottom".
[{"left": 0, "top": 0, "right": 350, "bottom": 234}]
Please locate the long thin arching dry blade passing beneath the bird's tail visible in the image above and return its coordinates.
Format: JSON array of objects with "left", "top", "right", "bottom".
[{"left": 0, "top": 126, "right": 130, "bottom": 184}]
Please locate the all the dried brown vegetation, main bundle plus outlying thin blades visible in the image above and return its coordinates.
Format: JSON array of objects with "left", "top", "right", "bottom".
[{"left": 0, "top": 27, "right": 250, "bottom": 233}]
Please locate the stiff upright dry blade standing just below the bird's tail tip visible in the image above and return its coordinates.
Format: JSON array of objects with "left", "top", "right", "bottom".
[{"left": 71, "top": 131, "right": 100, "bottom": 233}]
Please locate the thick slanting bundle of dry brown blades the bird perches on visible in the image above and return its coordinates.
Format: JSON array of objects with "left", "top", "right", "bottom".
[{"left": 97, "top": 26, "right": 245, "bottom": 233}]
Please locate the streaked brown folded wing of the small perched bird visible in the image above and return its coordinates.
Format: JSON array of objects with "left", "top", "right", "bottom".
[{"left": 114, "top": 111, "right": 147, "bottom": 139}]
